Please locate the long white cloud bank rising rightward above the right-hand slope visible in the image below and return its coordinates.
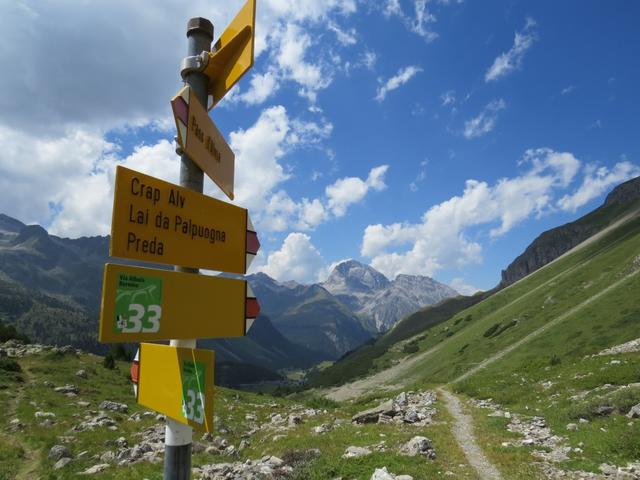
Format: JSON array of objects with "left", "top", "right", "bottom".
[{"left": 361, "top": 149, "right": 580, "bottom": 278}]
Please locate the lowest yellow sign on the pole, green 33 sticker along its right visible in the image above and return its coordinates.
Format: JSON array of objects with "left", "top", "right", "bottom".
[{"left": 137, "top": 343, "right": 214, "bottom": 432}]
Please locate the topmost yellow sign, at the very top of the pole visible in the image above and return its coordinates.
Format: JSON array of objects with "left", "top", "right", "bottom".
[{"left": 204, "top": 0, "right": 256, "bottom": 109}]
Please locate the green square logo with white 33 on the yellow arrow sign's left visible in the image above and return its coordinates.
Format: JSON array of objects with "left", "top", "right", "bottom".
[{"left": 113, "top": 273, "right": 162, "bottom": 333}]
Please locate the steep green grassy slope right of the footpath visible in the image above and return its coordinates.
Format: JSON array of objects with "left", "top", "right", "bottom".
[{"left": 320, "top": 209, "right": 640, "bottom": 479}]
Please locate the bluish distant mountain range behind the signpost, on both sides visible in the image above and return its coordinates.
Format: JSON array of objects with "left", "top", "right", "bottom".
[{"left": 0, "top": 214, "right": 456, "bottom": 376}]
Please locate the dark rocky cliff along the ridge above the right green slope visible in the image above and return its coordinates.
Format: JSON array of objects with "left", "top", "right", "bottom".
[{"left": 500, "top": 177, "right": 640, "bottom": 288}]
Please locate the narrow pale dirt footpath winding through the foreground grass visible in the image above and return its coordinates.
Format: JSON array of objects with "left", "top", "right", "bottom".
[{"left": 438, "top": 388, "right": 502, "bottom": 480}]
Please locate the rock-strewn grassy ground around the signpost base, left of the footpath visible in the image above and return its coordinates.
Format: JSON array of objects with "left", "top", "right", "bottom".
[{"left": 0, "top": 344, "right": 476, "bottom": 480}]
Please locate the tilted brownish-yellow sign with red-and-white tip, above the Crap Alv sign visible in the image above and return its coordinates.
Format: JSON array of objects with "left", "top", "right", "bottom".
[{"left": 171, "top": 85, "right": 235, "bottom": 200}]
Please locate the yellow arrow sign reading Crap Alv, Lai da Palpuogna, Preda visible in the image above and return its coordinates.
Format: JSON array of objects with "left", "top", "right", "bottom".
[{"left": 109, "top": 166, "right": 260, "bottom": 274}]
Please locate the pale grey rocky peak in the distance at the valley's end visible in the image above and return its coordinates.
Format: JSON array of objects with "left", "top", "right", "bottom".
[{"left": 322, "top": 260, "right": 458, "bottom": 332}]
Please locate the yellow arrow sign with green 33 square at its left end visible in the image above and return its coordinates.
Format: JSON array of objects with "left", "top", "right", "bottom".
[{"left": 98, "top": 264, "right": 260, "bottom": 343}]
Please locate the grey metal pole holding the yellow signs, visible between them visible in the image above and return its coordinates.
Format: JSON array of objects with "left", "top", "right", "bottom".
[{"left": 164, "top": 17, "right": 213, "bottom": 480}]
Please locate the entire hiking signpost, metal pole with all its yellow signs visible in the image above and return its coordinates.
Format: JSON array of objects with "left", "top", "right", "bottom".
[{"left": 99, "top": 0, "right": 260, "bottom": 480}]
